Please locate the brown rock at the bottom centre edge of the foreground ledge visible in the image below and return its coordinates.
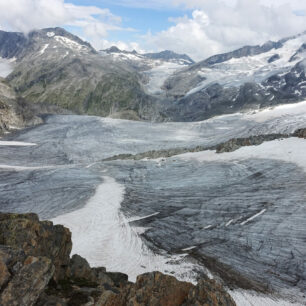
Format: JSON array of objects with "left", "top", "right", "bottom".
[{"left": 96, "top": 272, "right": 236, "bottom": 306}]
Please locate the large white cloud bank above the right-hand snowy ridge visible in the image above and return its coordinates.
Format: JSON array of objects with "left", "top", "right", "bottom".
[{"left": 145, "top": 0, "right": 306, "bottom": 60}]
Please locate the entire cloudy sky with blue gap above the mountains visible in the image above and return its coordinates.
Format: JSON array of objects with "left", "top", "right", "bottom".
[{"left": 0, "top": 0, "right": 306, "bottom": 61}]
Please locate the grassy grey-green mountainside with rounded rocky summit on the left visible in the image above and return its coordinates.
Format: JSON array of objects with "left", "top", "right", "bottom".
[{"left": 2, "top": 28, "right": 163, "bottom": 119}]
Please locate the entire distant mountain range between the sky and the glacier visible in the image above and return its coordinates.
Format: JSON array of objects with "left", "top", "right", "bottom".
[{"left": 0, "top": 28, "right": 306, "bottom": 130}]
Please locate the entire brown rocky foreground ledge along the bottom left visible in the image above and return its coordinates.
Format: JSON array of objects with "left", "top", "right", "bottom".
[{"left": 0, "top": 213, "right": 235, "bottom": 306}]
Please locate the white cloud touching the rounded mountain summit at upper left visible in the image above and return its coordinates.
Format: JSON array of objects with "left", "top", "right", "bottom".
[{"left": 0, "top": 0, "right": 126, "bottom": 41}]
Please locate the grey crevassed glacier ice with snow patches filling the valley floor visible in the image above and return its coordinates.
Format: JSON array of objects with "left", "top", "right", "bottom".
[{"left": 0, "top": 102, "right": 306, "bottom": 305}]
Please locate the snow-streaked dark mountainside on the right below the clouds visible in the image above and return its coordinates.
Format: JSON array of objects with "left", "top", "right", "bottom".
[{"left": 163, "top": 33, "right": 306, "bottom": 121}]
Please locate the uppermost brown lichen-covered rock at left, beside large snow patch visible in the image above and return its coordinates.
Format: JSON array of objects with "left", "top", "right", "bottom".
[{"left": 0, "top": 214, "right": 72, "bottom": 279}]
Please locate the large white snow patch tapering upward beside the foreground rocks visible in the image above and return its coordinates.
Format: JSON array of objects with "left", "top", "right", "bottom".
[{"left": 52, "top": 177, "right": 201, "bottom": 281}]
